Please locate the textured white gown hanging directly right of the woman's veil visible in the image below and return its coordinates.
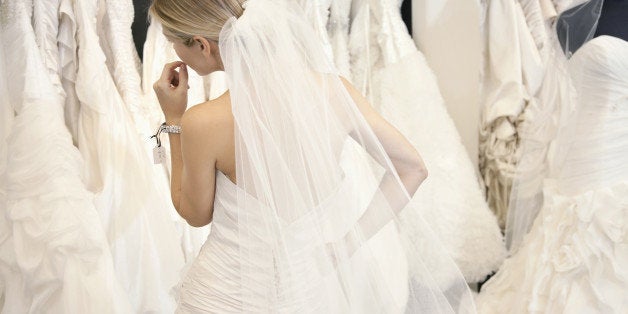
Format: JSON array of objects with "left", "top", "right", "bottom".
[{"left": 348, "top": 0, "right": 505, "bottom": 282}]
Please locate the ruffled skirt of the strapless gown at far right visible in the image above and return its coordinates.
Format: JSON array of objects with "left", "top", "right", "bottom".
[{"left": 478, "top": 180, "right": 628, "bottom": 313}]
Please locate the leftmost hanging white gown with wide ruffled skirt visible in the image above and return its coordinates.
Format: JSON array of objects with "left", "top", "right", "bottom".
[{"left": 0, "top": 0, "right": 131, "bottom": 313}]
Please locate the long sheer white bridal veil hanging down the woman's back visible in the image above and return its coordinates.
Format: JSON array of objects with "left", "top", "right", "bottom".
[{"left": 180, "top": 0, "right": 474, "bottom": 313}]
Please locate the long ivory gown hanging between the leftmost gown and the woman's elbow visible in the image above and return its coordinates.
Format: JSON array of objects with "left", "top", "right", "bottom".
[{"left": 74, "top": 0, "right": 184, "bottom": 312}]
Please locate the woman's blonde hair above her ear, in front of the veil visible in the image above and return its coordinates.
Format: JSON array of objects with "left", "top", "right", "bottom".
[{"left": 149, "top": 0, "right": 244, "bottom": 46}]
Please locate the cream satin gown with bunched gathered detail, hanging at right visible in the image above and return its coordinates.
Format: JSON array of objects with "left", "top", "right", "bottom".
[{"left": 480, "top": 0, "right": 546, "bottom": 228}]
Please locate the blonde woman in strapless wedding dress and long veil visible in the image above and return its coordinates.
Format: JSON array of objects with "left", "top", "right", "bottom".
[{"left": 150, "top": 0, "right": 473, "bottom": 313}]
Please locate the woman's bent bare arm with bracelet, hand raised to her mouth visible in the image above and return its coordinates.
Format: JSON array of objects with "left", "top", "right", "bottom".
[{"left": 153, "top": 61, "right": 217, "bottom": 227}]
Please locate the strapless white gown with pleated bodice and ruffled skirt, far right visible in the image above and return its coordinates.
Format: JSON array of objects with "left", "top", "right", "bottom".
[{"left": 478, "top": 36, "right": 628, "bottom": 313}]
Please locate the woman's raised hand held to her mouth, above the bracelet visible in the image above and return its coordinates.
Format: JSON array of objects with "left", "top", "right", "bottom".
[{"left": 153, "top": 61, "right": 189, "bottom": 122}]
